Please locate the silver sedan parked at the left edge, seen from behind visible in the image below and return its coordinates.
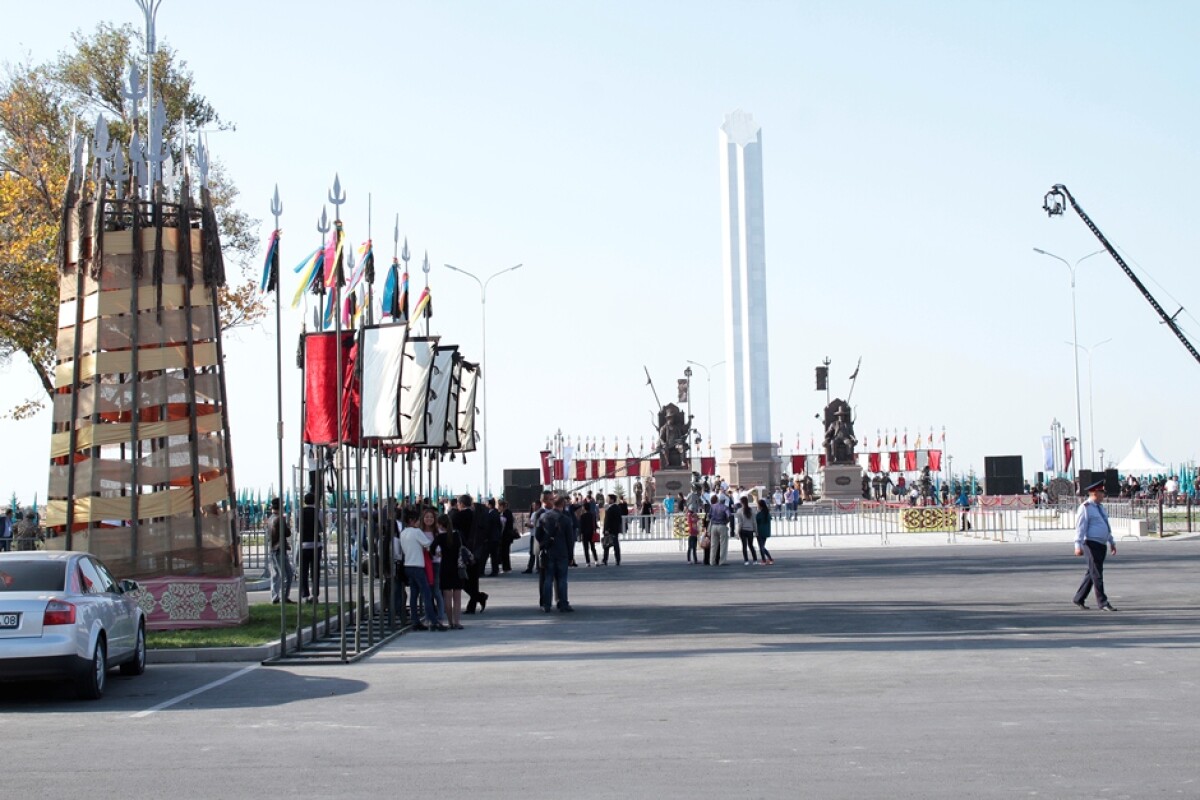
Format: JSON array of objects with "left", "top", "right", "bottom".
[{"left": 0, "top": 551, "right": 146, "bottom": 699}]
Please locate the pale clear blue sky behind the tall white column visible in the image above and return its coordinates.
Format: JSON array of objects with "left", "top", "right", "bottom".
[{"left": 0, "top": 0, "right": 1200, "bottom": 497}]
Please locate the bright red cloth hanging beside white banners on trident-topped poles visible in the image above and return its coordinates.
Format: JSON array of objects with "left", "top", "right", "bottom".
[{"left": 304, "top": 332, "right": 361, "bottom": 446}]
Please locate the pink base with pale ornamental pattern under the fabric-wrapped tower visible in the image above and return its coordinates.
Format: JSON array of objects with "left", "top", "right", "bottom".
[{"left": 131, "top": 576, "right": 250, "bottom": 631}]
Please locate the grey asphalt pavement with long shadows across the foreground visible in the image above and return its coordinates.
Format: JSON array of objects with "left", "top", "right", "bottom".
[{"left": 0, "top": 540, "right": 1200, "bottom": 798}]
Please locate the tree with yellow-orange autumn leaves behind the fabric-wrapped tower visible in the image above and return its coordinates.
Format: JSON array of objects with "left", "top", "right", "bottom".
[{"left": 0, "top": 23, "right": 266, "bottom": 415}]
